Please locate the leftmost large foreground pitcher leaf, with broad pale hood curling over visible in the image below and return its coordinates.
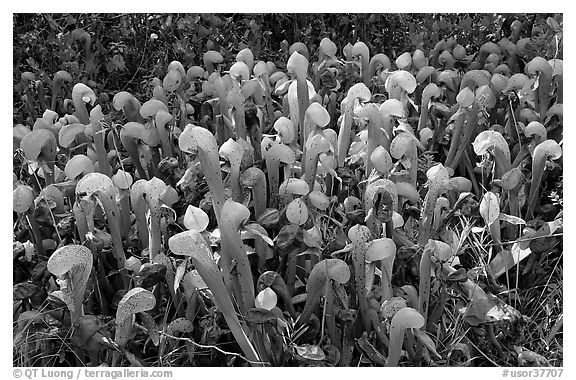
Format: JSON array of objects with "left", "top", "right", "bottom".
[{"left": 47, "top": 244, "right": 93, "bottom": 324}]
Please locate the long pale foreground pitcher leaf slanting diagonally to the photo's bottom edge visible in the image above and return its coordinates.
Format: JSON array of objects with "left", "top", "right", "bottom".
[{"left": 168, "top": 231, "right": 259, "bottom": 361}]
